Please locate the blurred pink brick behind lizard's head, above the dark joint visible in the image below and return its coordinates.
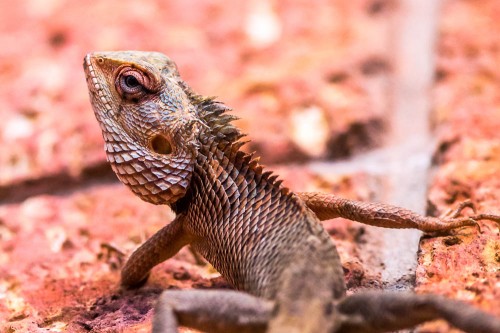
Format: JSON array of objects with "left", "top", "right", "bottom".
[{"left": 0, "top": 0, "right": 390, "bottom": 184}]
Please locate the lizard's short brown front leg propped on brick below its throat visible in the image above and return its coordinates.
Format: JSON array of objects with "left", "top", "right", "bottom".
[{"left": 121, "top": 215, "right": 191, "bottom": 288}]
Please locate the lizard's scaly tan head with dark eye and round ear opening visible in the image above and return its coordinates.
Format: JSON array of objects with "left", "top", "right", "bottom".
[{"left": 84, "top": 51, "right": 202, "bottom": 204}]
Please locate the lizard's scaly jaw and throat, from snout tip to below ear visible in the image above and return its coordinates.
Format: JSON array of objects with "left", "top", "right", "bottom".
[{"left": 83, "top": 52, "right": 196, "bottom": 204}]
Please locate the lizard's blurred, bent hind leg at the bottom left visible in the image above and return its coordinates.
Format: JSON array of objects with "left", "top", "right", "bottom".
[{"left": 153, "top": 290, "right": 273, "bottom": 333}]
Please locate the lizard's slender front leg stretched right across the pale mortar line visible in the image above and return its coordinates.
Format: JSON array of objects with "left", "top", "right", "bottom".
[{"left": 297, "top": 192, "right": 500, "bottom": 232}]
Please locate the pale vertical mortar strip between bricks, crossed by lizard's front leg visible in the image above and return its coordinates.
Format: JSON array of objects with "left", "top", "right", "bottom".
[{"left": 382, "top": 0, "right": 440, "bottom": 289}]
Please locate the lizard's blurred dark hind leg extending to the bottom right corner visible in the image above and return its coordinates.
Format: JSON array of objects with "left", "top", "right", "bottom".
[{"left": 337, "top": 291, "right": 500, "bottom": 333}]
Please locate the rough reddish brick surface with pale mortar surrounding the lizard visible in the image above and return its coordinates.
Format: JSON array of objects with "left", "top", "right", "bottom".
[{"left": 0, "top": 0, "right": 500, "bottom": 332}]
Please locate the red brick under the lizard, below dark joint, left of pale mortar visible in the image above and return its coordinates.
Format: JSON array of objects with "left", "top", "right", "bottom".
[{"left": 0, "top": 167, "right": 380, "bottom": 332}]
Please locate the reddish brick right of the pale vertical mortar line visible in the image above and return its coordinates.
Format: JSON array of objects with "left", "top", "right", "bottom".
[{"left": 416, "top": 1, "right": 500, "bottom": 332}]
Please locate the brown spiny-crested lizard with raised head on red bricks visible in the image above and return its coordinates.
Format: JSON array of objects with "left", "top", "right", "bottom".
[{"left": 83, "top": 51, "right": 500, "bottom": 333}]
